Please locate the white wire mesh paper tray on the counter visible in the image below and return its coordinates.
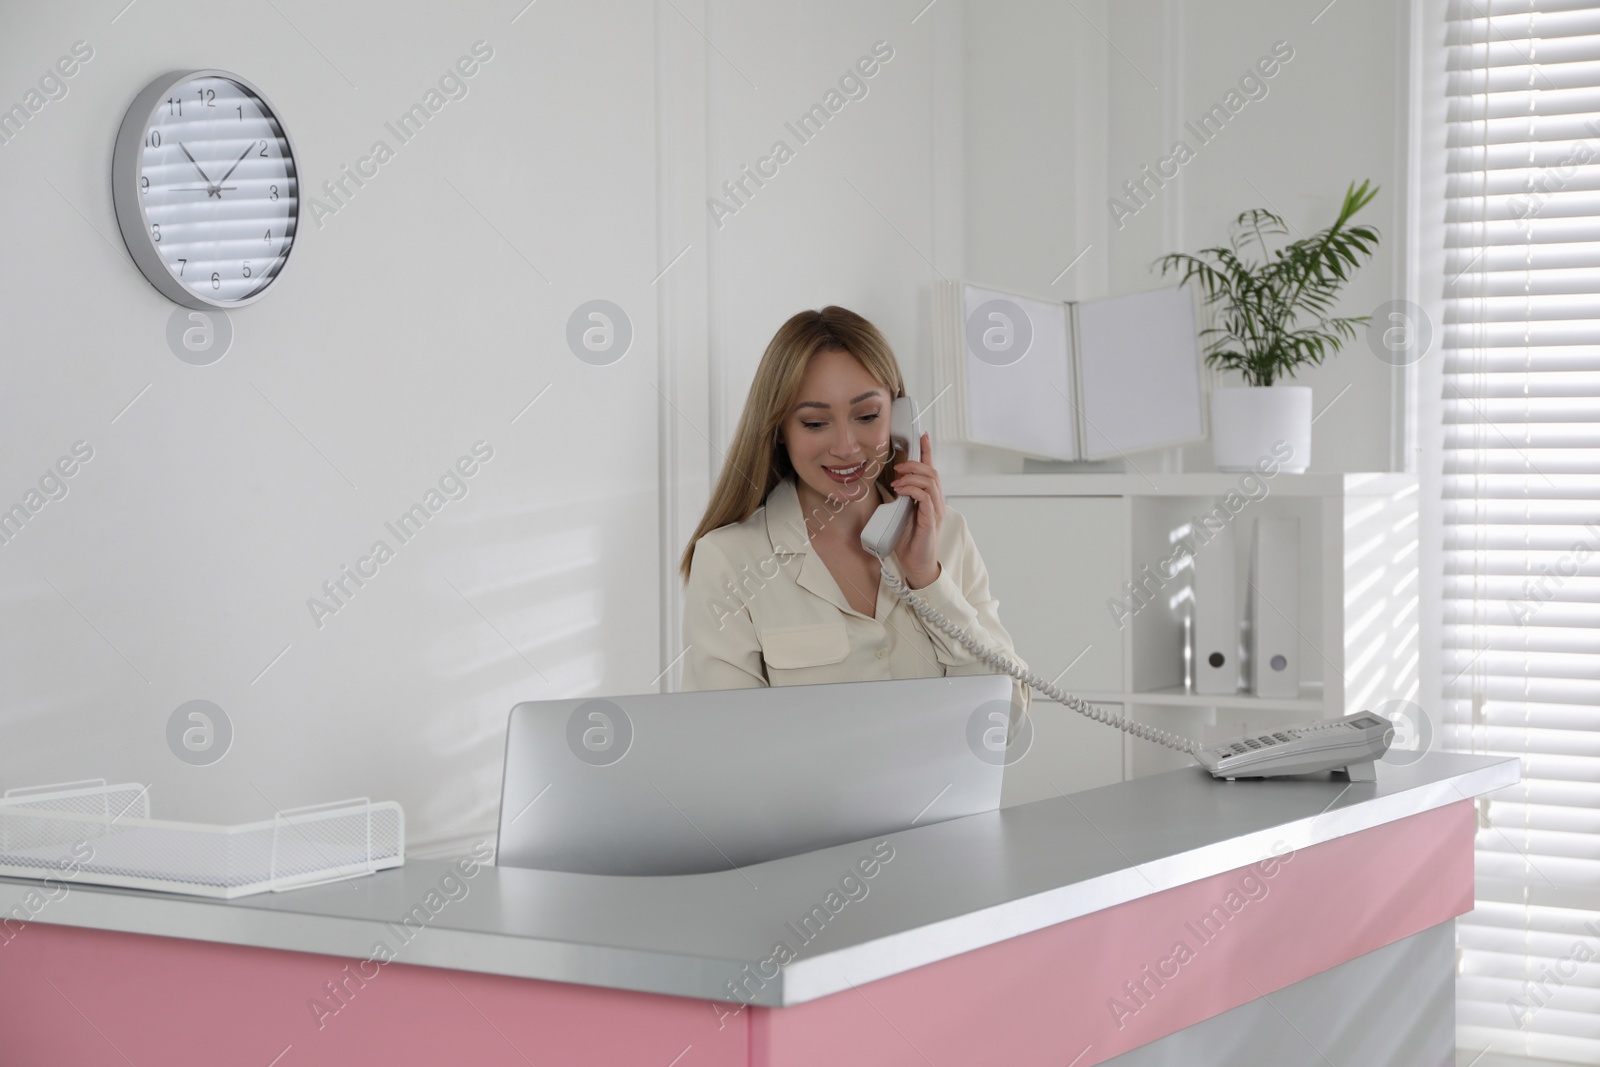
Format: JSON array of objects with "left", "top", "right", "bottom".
[{"left": 0, "top": 779, "right": 405, "bottom": 899}]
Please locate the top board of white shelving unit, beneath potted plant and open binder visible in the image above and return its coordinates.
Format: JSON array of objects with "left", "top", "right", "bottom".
[{"left": 941, "top": 470, "right": 1416, "bottom": 496}]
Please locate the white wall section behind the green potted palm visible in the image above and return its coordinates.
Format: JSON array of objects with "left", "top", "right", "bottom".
[{"left": 1106, "top": 0, "right": 1408, "bottom": 470}]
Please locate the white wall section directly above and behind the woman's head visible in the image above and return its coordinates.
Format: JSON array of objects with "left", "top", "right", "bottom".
[{"left": 707, "top": 0, "right": 962, "bottom": 462}]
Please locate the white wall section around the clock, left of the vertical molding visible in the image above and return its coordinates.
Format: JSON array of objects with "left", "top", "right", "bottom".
[{"left": 0, "top": 0, "right": 661, "bottom": 848}]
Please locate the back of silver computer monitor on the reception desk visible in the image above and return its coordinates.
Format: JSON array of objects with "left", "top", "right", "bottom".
[{"left": 494, "top": 673, "right": 1011, "bottom": 875}]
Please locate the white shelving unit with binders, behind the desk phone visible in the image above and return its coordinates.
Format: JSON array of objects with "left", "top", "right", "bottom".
[{"left": 942, "top": 472, "right": 1418, "bottom": 805}]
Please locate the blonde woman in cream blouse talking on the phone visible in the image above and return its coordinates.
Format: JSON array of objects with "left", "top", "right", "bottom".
[{"left": 680, "top": 307, "right": 1030, "bottom": 713}]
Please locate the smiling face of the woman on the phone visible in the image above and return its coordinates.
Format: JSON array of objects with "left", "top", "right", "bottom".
[{"left": 782, "top": 349, "right": 890, "bottom": 501}]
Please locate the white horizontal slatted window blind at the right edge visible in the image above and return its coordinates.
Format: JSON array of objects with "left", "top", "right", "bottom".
[{"left": 1438, "top": 0, "right": 1600, "bottom": 1064}]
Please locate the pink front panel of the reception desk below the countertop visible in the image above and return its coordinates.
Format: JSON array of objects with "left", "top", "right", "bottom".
[{"left": 0, "top": 801, "right": 1475, "bottom": 1067}]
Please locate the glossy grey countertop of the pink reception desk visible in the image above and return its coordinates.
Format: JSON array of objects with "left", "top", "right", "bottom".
[{"left": 0, "top": 752, "right": 1520, "bottom": 1006}]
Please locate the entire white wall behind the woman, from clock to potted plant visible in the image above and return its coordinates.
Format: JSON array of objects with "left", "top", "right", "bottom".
[{"left": 0, "top": 0, "right": 1403, "bottom": 851}]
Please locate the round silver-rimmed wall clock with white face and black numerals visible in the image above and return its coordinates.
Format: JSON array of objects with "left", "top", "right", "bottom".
[{"left": 112, "top": 70, "right": 299, "bottom": 310}]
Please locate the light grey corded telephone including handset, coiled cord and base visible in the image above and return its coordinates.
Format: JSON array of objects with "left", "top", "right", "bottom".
[{"left": 861, "top": 397, "right": 1395, "bottom": 782}]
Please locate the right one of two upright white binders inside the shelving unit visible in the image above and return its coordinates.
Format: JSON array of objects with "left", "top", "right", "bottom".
[{"left": 1248, "top": 518, "right": 1301, "bottom": 697}]
